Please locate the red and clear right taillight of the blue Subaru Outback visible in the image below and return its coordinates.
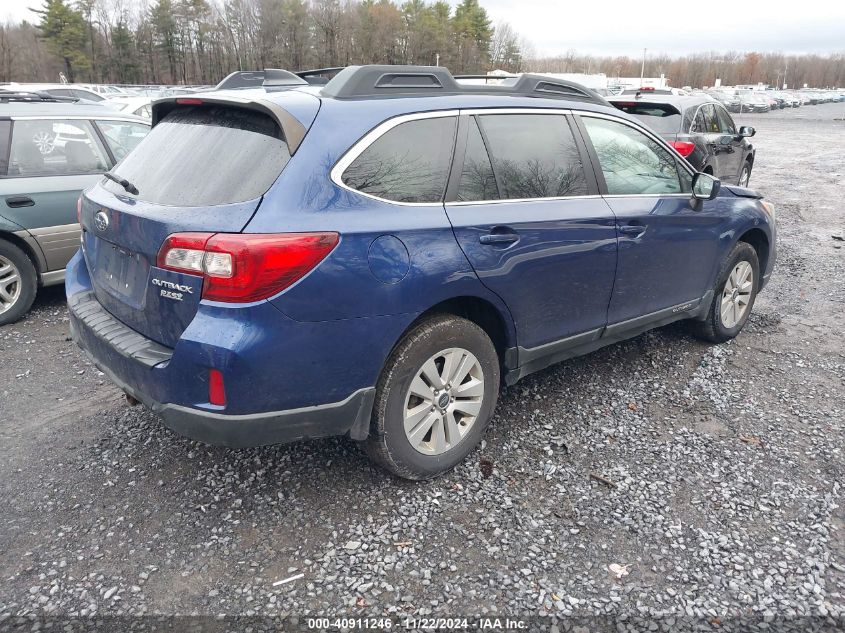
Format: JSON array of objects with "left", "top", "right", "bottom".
[{"left": 157, "top": 233, "right": 340, "bottom": 303}]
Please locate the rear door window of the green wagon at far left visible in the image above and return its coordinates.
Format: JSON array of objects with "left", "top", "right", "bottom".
[{"left": 9, "top": 119, "right": 110, "bottom": 176}]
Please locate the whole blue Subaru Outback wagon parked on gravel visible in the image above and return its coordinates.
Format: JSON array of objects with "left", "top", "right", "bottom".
[{"left": 66, "top": 66, "right": 775, "bottom": 479}]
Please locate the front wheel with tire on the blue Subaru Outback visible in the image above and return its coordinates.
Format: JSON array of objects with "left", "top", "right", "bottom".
[{"left": 692, "top": 242, "right": 760, "bottom": 343}]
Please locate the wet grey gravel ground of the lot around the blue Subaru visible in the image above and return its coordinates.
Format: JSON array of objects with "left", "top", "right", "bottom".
[{"left": 0, "top": 104, "right": 845, "bottom": 631}]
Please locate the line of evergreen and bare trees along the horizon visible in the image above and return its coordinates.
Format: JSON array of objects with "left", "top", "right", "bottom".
[{"left": 0, "top": 0, "right": 845, "bottom": 88}]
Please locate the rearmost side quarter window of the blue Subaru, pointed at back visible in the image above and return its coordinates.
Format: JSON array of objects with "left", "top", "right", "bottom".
[{"left": 341, "top": 116, "right": 457, "bottom": 203}]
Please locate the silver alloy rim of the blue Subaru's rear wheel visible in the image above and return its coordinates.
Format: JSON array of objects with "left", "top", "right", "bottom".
[{"left": 403, "top": 347, "right": 484, "bottom": 455}]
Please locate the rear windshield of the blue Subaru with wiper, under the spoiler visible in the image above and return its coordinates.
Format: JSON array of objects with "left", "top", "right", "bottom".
[{"left": 103, "top": 106, "right": 290, "bottom": 207}]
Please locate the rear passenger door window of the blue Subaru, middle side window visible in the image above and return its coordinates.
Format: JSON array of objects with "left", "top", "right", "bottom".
[{"left": 477, "top": 114, "right": 587, "bottom": 200}]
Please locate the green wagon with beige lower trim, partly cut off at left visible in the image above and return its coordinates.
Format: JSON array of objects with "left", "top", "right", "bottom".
[{"left": 0, "top": 102, "right": 150, "bottom": 325}]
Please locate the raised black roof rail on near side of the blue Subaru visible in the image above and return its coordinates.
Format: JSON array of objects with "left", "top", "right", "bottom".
[{"left": 322, "top": 65, "right": 610, "bottom": 106}]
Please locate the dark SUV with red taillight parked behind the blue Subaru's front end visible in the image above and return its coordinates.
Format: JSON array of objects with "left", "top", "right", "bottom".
[{"left": 609, "top": 94, "right": 755, "bottom": 187}]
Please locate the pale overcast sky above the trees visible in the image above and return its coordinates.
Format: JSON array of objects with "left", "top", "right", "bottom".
[{"left": 0, "top": 0, "right": 845, "bottom": 58}]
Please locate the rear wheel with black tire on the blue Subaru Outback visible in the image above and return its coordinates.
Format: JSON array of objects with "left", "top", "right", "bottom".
[{"left": 366, "top": 315, "right": 500, "bottom": 480}]
